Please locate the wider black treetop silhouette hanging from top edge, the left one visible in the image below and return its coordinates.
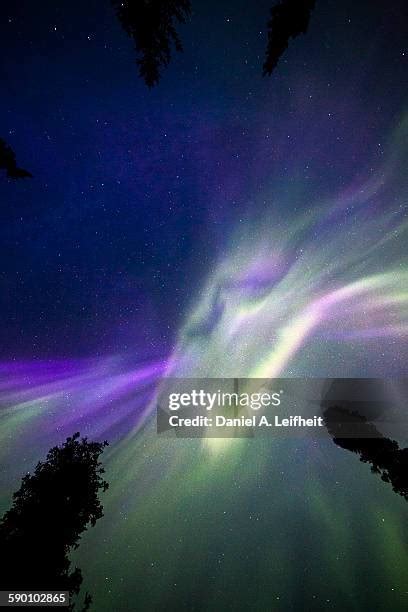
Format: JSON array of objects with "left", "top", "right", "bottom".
[{"left": 111, "top": 0, "right": 191, "bottom": 87}]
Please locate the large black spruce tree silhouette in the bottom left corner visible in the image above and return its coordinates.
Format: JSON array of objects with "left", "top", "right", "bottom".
[{"left": 0, "top": 433, "right": 109, "bottom": 609}]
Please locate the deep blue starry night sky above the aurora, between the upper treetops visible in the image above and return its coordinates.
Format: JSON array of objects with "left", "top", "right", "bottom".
[{"left": 0, "top": 1, "right": 408, "bottom": 358}]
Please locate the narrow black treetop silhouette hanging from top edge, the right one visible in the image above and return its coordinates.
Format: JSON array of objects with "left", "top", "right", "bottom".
[{"left": 263, "top": 0, "right": 316, "bottom": 76}]
